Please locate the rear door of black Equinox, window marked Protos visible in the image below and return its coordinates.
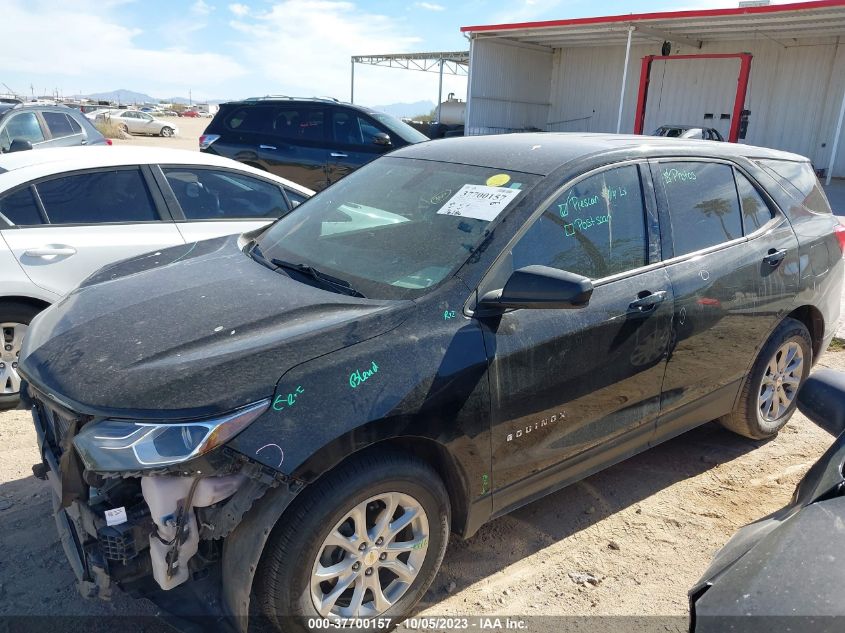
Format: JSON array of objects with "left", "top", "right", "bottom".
[{"left": 652, "top": 159, "right": 798, "bottom": 435}]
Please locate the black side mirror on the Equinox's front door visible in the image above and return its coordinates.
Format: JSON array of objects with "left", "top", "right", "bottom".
[{"left": 478, "top": 266, "right": 593, "bottom": 312}]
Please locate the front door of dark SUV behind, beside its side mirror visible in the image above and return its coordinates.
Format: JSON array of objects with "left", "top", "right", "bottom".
[{"left": 328, "top": 107, "right": 395, "bottom": 183}]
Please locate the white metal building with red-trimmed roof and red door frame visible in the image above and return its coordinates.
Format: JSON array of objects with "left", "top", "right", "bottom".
[{"left": 461, "top": 0, "right": 845, "bottom": 177}]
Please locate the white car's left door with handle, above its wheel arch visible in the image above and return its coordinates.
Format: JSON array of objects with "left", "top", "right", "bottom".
[{"left": 3, "top": 167, "right": 184, "bottom": 294}]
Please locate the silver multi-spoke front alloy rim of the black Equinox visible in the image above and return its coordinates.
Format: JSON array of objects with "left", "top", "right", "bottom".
[{"left": 311, "top": 492, "right": 429, "bottom": 618}]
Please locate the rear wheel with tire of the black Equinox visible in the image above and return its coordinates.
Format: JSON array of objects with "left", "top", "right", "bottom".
[{"left": 719, "top": 318, "right": 813, "bottom": 440}]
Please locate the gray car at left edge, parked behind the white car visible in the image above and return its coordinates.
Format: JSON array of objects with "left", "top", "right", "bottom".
[{"left": 0, "top": 103, "right": 111, "bottom": 154}]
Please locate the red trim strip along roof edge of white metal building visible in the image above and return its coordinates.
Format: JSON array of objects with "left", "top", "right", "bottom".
[{"left": 461, "top": 0, "right": 845, "bottom": 33}]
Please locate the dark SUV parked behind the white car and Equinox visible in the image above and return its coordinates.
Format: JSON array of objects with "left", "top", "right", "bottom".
[{"left": 200, "top": 97, "right": 428, "bottom": 191}]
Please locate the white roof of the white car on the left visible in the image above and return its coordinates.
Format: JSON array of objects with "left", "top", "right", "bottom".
[{"left": 0, "top": 145, "right": 314, "bottom": 195}]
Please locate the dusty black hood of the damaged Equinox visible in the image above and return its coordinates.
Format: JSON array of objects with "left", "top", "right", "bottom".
[{"left": 20, "top": 236, "right": 413, "bottom": 419}]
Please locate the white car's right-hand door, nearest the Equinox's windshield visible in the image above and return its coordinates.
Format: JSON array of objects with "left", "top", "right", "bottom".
[{"left": 155, "top": 165, "right": 292, "bottom": 242}]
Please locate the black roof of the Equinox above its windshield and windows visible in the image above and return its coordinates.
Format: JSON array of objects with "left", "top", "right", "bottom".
[{"left": 390, "top": 132, "right": 809, "bottom": 176}]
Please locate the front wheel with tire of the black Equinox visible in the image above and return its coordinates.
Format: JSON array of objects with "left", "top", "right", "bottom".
[{"left": 255, "top": 452, "right": 450, "bottom": 633}]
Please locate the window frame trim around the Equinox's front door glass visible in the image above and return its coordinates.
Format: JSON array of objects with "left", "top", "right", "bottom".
[{"left": 472, "top": 158, "right": 664, "bottom": 308}]
